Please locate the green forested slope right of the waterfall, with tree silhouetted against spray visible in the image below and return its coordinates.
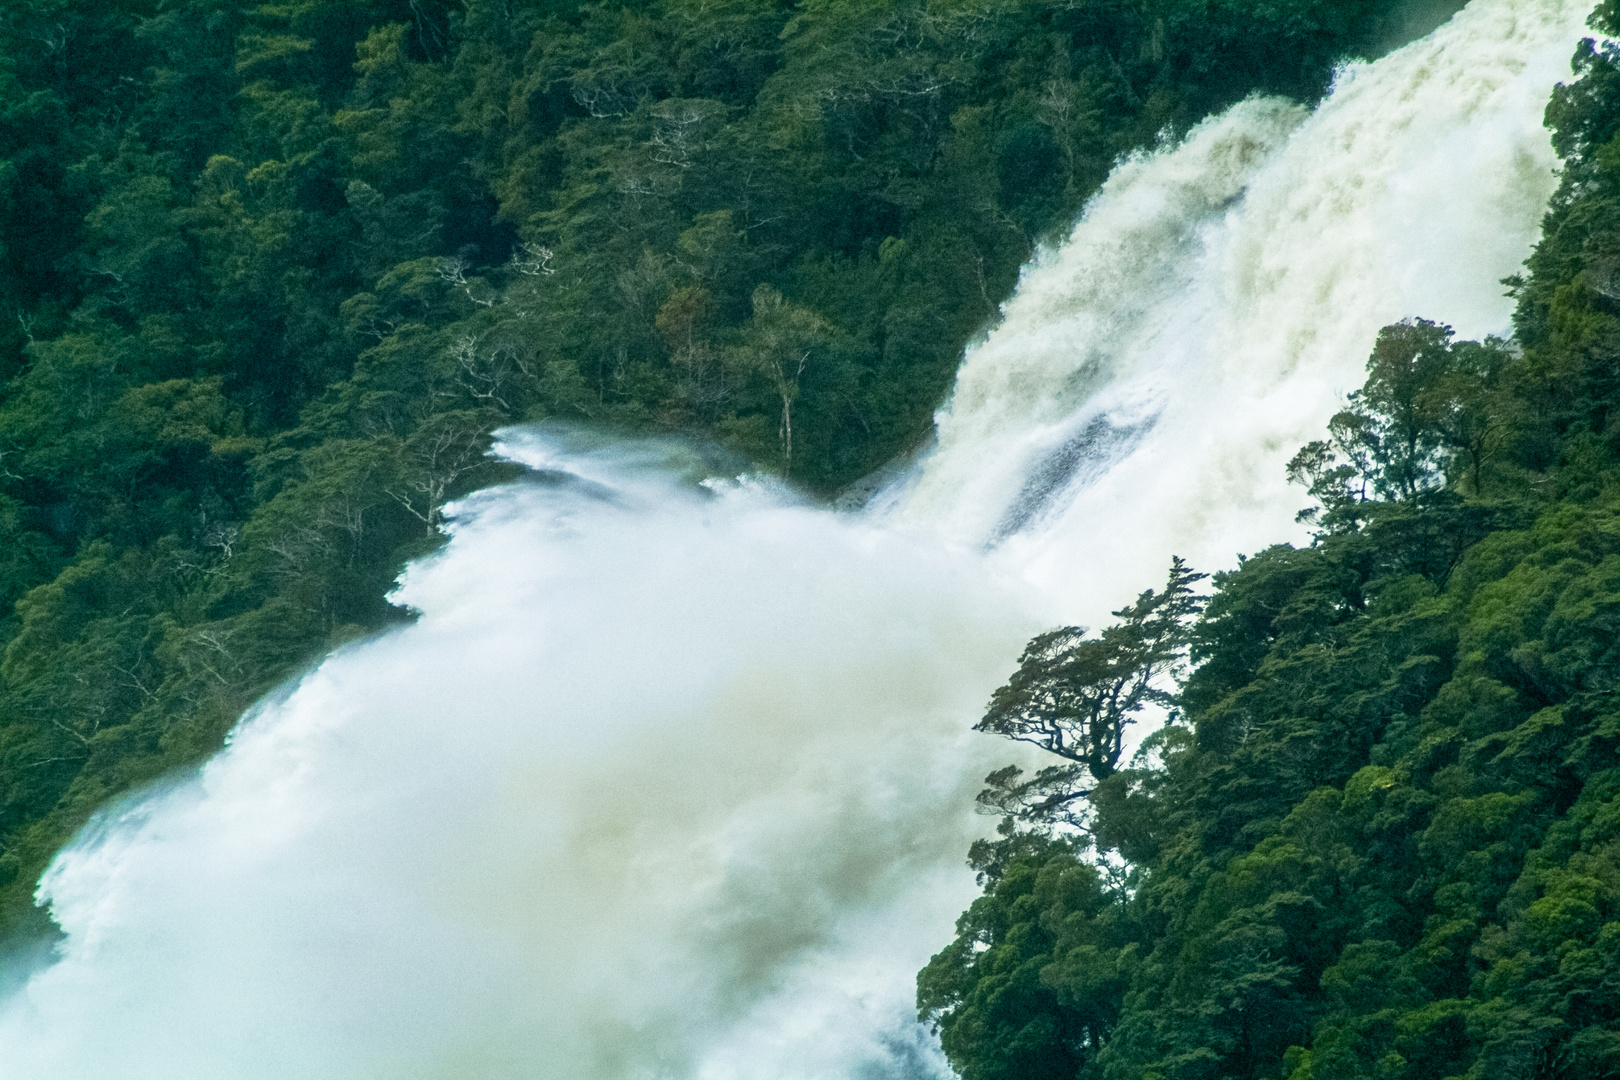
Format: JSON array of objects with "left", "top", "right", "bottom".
[{"left": 919, "top": 0, "right": 1620, "bottom": 1080}]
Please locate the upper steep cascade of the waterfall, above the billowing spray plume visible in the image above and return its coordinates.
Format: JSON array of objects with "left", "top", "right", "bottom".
[{"left": 891, "top": 0, "right": 1591, "bottom": 619}]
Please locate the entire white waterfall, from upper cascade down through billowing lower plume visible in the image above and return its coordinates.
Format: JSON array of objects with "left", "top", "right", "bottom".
[{"left": 0, "top": 0, "right": 1584, "bottom": 1080}]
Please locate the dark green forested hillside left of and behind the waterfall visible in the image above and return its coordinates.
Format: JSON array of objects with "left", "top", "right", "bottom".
[{"left": 0, "top": 0, "right": 1432, "bottom": 934}]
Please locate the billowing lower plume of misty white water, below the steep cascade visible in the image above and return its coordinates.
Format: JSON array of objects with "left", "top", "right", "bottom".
[{"left": 0, "top": 434, "right": 1030, "bottom": 1080}]
